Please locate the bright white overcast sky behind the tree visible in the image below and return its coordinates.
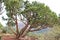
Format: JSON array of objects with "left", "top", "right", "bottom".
[{"left": 0, "top": 0, "right": 60, "bottom": 26}]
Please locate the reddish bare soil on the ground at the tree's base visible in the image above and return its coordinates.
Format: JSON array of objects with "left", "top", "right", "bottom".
[{"left": 2, "top": 35, "right": 38, "bottom": 40}]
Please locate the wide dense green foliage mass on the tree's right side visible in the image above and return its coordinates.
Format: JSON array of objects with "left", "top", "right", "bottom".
[{"left": 21, "top": 2, "right": 57, "bottom": 27}]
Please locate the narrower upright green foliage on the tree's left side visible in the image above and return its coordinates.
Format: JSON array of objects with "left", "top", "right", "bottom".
[{"left": 3, "top": 0, "right": 22, "bottom": 26}]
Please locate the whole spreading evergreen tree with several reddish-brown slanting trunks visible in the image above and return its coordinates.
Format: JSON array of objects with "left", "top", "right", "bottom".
[{"left": 3, "top": 0, "right": 57, "bottom": 40}]
